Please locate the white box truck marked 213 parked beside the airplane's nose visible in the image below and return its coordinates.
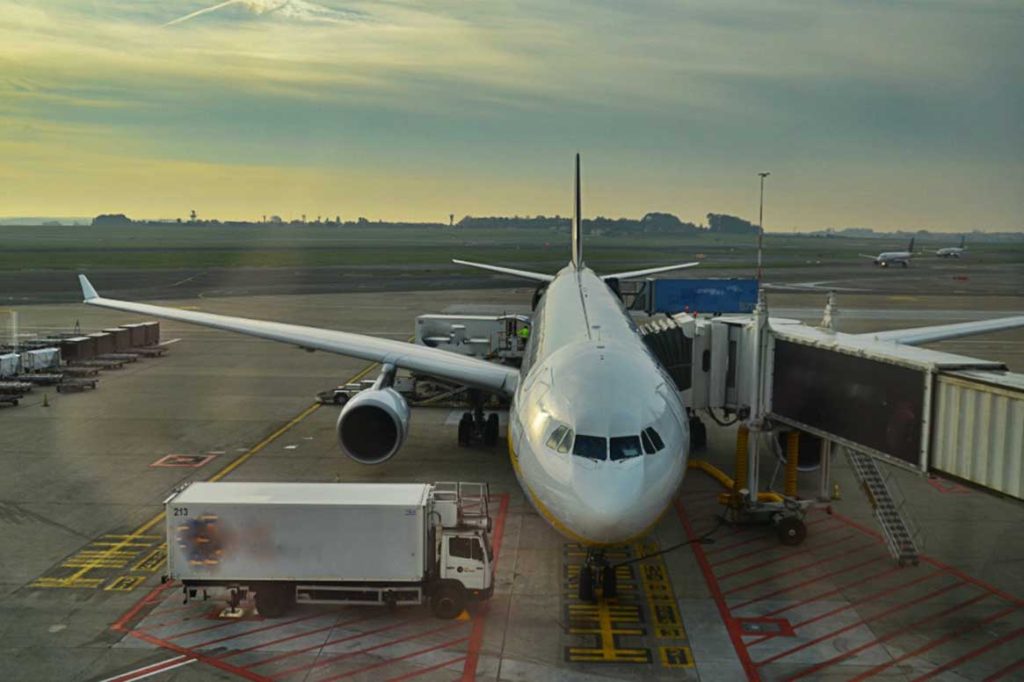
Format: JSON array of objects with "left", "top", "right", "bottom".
[{"left": 164, "top": 482, "right": 494, "bottom": 619}]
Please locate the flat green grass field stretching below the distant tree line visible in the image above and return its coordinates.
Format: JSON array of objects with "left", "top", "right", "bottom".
[{"left": 0, "top": 225, "right": 1024, "bottom": 271}]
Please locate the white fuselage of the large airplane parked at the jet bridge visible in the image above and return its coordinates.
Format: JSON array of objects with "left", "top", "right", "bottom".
[{"left": 508, "top": 265, "right": 689, "bottom": 545}]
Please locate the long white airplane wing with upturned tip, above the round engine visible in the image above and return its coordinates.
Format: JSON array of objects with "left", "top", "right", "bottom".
[{"left": 78, "top": 274, "right": 519, "bottom": 395}]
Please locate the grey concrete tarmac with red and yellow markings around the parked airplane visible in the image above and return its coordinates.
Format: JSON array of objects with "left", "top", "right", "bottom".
[{"left": 0, "top": 271, "right": 1024, "bottom": 681}]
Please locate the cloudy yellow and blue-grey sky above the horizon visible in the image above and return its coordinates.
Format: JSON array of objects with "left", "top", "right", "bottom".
[{"left": 0, "top": 0, "right": 1024, "bottom": 231}]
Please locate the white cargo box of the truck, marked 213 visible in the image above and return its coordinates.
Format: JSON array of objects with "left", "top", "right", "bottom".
[{"left": 165, "top": 481, "right": 430, "bottom": 584}]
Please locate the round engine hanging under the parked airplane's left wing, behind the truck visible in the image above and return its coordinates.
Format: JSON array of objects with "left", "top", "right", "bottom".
[{"left": 338, "top": 388, "right": 409, "bottom": 464}]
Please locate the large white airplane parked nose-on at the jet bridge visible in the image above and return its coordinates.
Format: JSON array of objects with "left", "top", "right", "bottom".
[{"left": 79, "top": 155, "right": 1024, "bottom": 601}]
